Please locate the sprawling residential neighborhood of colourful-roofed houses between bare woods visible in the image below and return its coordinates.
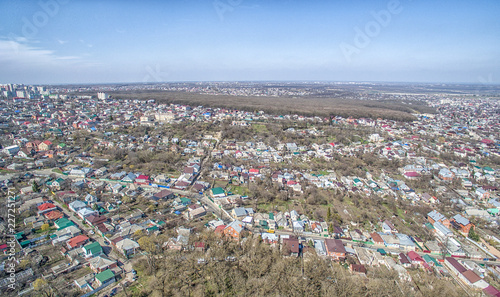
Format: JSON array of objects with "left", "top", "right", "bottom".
[{"left": 0, "top": 84, "right": 500, "bottom": 296}]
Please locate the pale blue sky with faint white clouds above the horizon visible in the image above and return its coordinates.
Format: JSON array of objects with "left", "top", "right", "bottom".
[{"left": 0, "top": 0, "right": 500, "bottom": 84}]
